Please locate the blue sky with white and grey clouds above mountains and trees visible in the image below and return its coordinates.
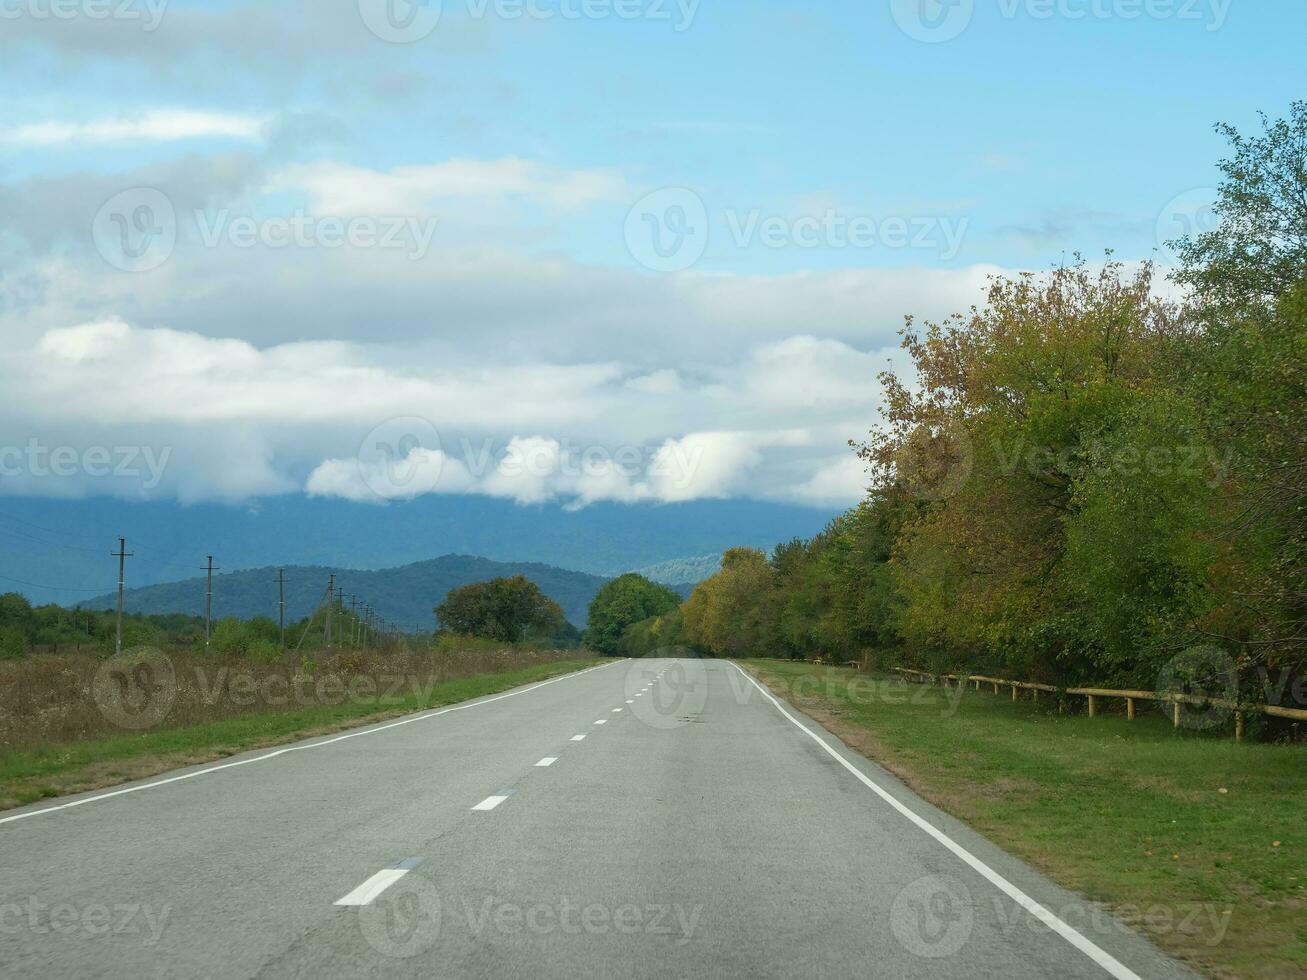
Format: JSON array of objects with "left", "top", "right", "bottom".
[{"left": 0, "top": 0, "right": 1307, "bottom": 508}]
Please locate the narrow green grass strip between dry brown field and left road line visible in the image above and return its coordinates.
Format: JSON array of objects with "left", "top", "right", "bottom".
[{"left": 0, "top": 659, "right": 601, "bottom": 809}]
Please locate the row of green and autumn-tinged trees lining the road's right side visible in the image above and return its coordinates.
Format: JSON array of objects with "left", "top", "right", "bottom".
[{"left": 606, "top": 102, "right": 1307, "bottom": 686}]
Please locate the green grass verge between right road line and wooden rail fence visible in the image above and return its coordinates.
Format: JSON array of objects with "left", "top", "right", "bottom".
[{"left": 745, "top": 661, "right": 1307, "bottom": 980}]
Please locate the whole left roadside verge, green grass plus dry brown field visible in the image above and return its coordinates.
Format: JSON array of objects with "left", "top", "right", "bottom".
[{"left": 0, "top": 649, "right": 600, "bottom": 809}]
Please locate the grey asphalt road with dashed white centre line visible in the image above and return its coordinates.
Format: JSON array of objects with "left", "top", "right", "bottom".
[{"left": 0, "top": 660, "right": 1189, "bottom": 980}]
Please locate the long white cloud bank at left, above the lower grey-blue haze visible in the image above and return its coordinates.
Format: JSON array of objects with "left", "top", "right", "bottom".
[{"left": 19, "top": 320, "right": 622, "bottom": 430}]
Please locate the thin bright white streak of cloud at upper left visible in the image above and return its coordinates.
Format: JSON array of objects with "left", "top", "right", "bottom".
[{"left": 0, "top": 108, "right": 268, "bottom": 146}]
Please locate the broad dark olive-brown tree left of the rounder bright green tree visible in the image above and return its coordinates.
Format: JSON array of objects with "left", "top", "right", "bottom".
[{"left": 435, "top": 575, "right": 567, "bottom": 643}]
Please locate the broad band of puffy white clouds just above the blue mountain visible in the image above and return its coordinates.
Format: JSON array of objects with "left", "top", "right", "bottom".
[{"left": 0, "top": 319, "right": 904, "bottom": 507}]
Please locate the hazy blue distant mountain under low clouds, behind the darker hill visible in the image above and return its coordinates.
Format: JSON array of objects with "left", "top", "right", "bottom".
[{"left": 0, "top": 495, "right": 834, "bottom": 605}]
